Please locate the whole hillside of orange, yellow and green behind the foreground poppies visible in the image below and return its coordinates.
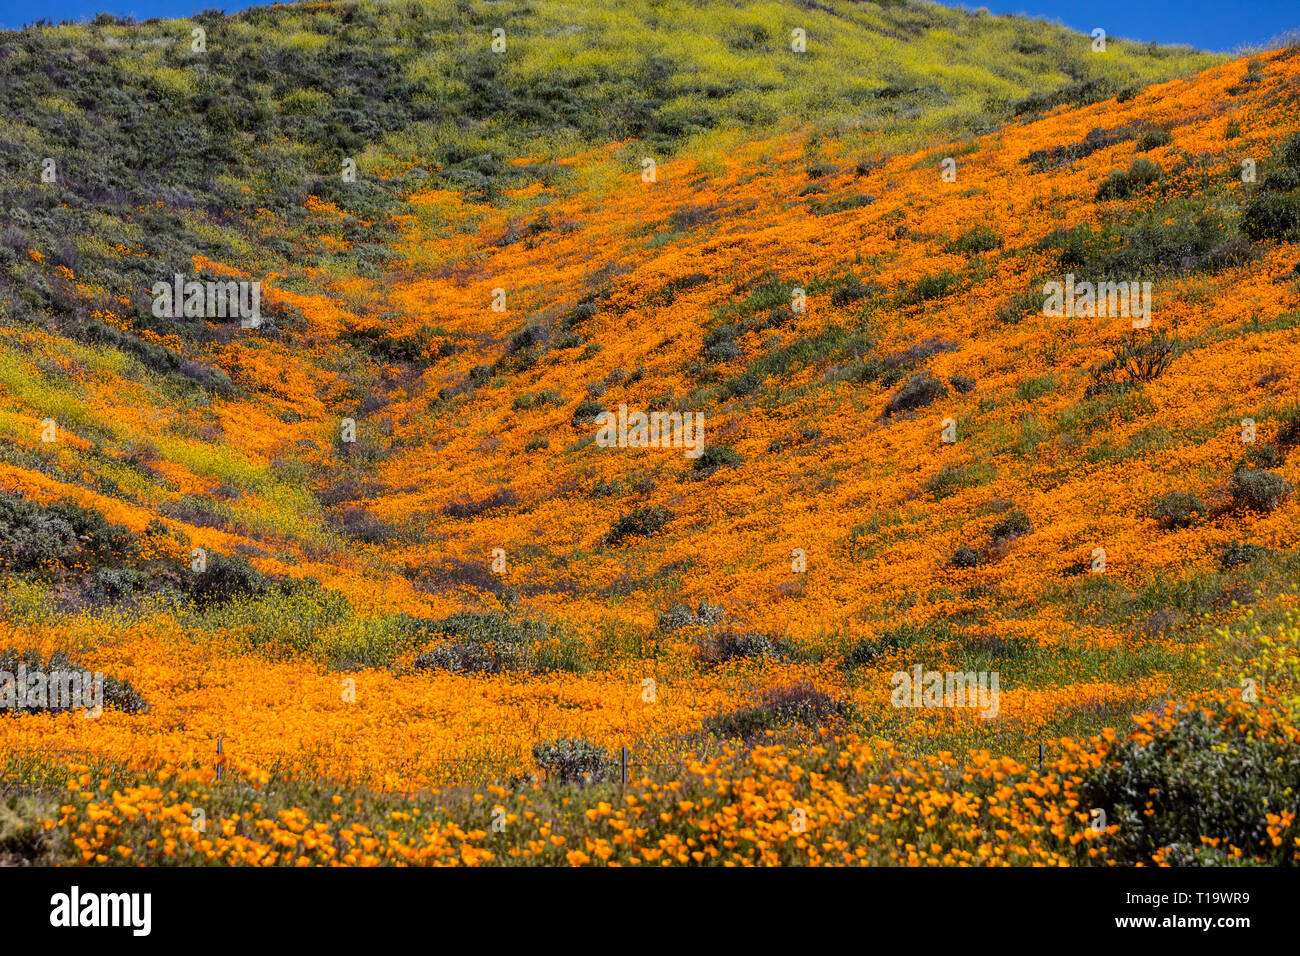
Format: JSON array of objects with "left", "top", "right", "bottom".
[{"left": 0, "top": 0, "right": 1300, "bottom": 862}]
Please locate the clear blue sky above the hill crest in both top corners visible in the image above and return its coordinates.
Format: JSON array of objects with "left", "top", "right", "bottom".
[{"left": 0, "top": 0, "right": 1300, "bottom": 52}]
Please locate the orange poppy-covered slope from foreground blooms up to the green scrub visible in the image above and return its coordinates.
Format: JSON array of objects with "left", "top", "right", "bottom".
[{"left": 0, "top": 7, "right": 1300, "bottom": 862}]
